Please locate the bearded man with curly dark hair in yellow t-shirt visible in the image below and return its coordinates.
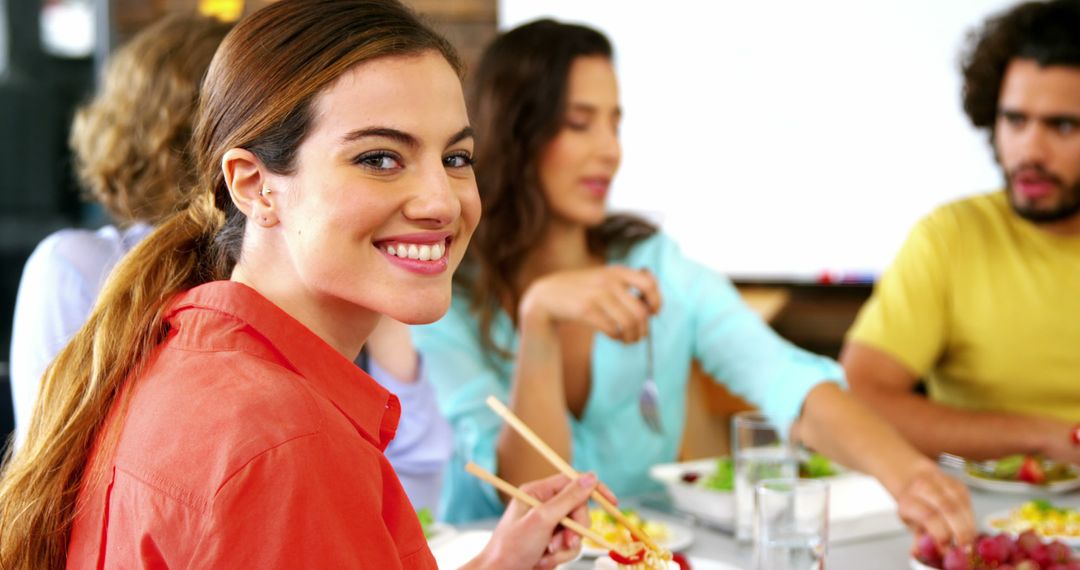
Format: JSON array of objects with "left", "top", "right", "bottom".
[{"left": 841, "top": 0, "right": 1080, "bottom": 463}]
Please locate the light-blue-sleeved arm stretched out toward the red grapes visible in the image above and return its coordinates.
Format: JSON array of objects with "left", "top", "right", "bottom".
[{"left": 663, "top": 236, "right": 974, "bottom": 543}]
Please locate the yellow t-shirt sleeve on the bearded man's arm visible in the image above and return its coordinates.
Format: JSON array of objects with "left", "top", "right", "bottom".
[{"left": 848, "top": 209, "right": 954, "bottom": 376}]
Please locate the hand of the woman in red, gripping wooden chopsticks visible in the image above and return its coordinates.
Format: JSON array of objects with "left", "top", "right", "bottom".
[{"left": 465, "top": 474, "right": 613, "bottom": 570}]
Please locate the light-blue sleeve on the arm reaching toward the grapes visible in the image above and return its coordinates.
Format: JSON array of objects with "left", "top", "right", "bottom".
[{"left": 659, "top": 240, "right": 843, "bottom": 434}]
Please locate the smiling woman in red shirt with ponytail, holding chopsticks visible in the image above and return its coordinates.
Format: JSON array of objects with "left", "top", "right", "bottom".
[{"left": 0, "top": 0, "right": 595, "bottom": 569}]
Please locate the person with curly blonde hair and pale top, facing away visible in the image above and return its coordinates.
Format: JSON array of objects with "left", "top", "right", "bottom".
[{"left": 11, "top": 15, "right": 229, "bottom": 445}]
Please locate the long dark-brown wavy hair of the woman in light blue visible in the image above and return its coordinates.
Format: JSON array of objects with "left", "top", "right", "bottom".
[{"left": 455, "top": 19, "right": 656, "bottom": 355}]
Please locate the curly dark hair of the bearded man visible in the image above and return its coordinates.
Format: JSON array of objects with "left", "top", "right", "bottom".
[{"left": 961, "top": 0, "right": 1080, "bottom": 136}]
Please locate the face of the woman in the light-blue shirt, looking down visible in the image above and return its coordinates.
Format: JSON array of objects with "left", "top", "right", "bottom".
[{"left": 539, "top": 56, "right": 622, "bottom": 227}]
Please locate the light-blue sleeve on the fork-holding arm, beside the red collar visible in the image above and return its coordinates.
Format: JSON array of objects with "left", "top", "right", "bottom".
[{"left": 411, "top": 299, "right": 510, "bottom": 523}]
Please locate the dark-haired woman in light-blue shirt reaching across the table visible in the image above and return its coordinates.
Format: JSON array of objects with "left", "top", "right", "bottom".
[{"left": 414, "top": 21, "right": 974, "bottom": 542}]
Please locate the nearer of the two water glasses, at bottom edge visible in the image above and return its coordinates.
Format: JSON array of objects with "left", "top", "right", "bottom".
[{"left": 754, "top": 478, "right": 828, "bottom": 570}]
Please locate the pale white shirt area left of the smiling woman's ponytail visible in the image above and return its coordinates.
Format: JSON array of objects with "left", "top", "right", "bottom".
[{"left": 11, "top": 223, "right": 152, "bottom": 448}]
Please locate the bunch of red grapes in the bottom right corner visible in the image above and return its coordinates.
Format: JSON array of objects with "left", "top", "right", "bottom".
[{"left": 912, "top": 530, "right": 1080, "bottom": 570}]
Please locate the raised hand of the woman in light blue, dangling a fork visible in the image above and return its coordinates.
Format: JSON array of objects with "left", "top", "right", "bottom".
[{"left": 518, "top": 266, "right": 660, "bottom": 343}]
